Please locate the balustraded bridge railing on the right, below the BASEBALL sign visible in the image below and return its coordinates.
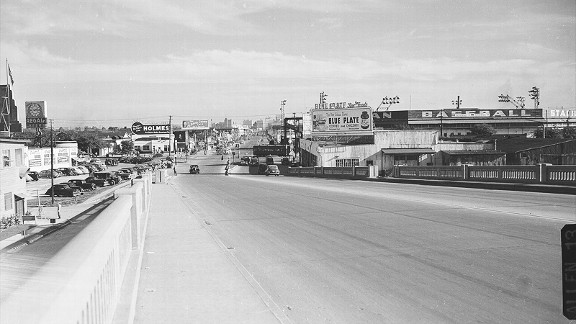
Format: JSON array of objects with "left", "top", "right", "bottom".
[{"left": 393, "top": 164, "right": 576, "bottom": 186}]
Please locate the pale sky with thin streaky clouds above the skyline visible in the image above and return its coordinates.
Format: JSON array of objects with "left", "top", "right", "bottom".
[{"left": 0, "top": 0, "right": 576, "bottom": 126}]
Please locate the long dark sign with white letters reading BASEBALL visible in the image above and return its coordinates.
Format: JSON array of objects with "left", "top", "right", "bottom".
[{"left": 408, "top": 108, "right": 542, "bottom": 120}]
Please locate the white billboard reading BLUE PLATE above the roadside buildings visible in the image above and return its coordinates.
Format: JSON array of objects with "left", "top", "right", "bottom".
[{"left": 312, "top": 107, "right": 372, "bottom": 135}]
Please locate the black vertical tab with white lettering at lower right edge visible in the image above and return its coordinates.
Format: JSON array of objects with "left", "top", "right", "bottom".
[{"left": 560, "top": 224, "right": 576, "bottom": 320}]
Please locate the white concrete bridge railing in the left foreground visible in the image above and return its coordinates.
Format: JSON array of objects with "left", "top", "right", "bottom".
[{"left": 0, "top": 175, "right": 152, "bottom": 324}]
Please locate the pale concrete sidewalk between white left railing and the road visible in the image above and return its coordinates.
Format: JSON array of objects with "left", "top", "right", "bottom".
[{"left": 128, "top": 179, "right": 289, "bottom": 323}]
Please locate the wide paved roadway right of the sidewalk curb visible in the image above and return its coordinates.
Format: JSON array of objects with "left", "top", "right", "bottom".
[{"left": 172, "top": 155, "right": 576, "bottom": 323}]
